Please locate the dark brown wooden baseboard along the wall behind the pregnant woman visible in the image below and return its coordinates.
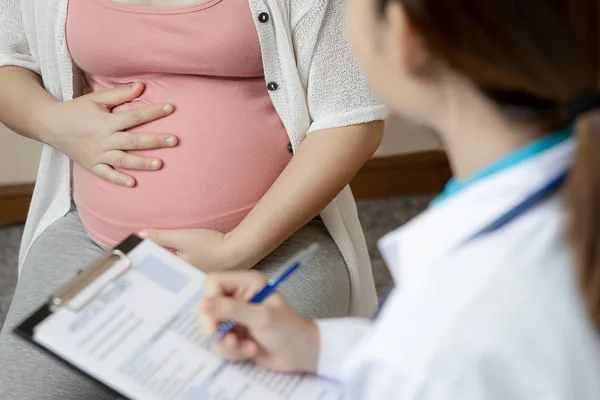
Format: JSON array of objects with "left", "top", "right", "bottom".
[{"left": 0, "top": 151, "right": 451, "bottom": 226}]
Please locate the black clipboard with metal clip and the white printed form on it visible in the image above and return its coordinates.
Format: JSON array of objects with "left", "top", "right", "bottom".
[{"left": 14, "top": 236, "right": 341, "bottom": 400}]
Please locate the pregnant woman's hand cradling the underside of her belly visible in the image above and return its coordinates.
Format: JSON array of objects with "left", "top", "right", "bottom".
[{"left": 140, "top": 229, "right": 243, "bottom": 273}]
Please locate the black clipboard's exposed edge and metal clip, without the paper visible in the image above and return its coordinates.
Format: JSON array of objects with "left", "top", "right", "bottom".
[{"left": 13, "top": 235, "right": 143, "bottom": 400}]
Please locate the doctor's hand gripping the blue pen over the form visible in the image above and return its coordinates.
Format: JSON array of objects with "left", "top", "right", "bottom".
[{"left": 200, "top": 271, "right": 319, "bottom": 373}]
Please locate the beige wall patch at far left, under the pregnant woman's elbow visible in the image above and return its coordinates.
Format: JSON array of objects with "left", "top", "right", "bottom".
[{"left": 0, "top": 124, "right": 41, "bottom": 186}]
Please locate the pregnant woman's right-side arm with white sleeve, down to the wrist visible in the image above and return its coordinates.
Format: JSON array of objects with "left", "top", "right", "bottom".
[{"left": 220, "top": 0, "right": 387, "bottom": 268}]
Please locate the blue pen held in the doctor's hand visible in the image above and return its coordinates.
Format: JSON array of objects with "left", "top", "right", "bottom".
[{"left": 204, "top": 243, "right": 319, "bottom": 347}]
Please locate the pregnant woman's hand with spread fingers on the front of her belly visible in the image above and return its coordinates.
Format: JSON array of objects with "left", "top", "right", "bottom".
[{"left": 45, "top": 83, "right": 177, "bottom": 186}]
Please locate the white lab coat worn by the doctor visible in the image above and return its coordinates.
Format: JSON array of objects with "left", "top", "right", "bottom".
[{"left": 318, "top": 139, "right": 600, "bottom": 400}]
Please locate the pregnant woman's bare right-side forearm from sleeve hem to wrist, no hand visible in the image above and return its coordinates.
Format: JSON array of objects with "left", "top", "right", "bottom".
[{"left": 225, "top": 121, "right": 384, "bottom": 269}]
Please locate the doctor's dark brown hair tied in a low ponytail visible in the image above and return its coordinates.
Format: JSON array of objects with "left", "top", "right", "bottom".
[{"left": 377, "top": 0, "right": 600, "bottom": 329}]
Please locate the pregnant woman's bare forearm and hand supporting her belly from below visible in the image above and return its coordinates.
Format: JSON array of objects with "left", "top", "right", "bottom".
[{"left": 140, "top": 121, "right": 384, "bottom": 272}]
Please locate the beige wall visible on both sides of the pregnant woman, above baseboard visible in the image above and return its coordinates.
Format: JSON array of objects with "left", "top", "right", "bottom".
[{"left": 0, "top": 118, "right": 440, "bottom": 186}]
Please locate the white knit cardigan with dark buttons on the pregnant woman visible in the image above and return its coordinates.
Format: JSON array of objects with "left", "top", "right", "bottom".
[{"left": 0, "top": 0, "right": 387, "bottom": 316}]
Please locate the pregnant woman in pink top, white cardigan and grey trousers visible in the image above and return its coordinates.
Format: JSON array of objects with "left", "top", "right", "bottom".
[{"left": 0, "top": 0, "right": 386, "bottom": 399}]
